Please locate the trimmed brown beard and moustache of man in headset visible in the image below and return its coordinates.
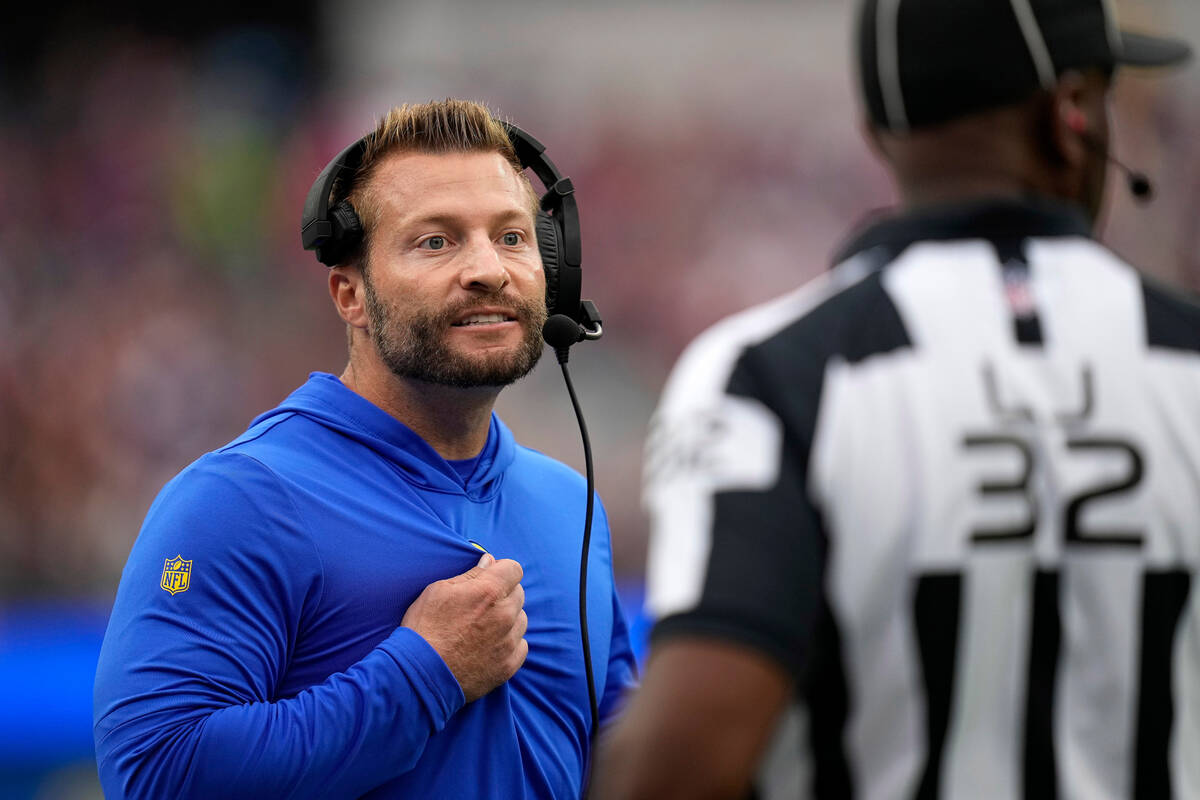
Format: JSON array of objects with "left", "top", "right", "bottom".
[{"left": 364, "top": 275, "right": 547, "bottom": 389}]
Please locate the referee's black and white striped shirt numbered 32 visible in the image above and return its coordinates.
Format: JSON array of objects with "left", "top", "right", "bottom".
[{"left": 646, "top": 196, "right": 1200, "bottom": 800}]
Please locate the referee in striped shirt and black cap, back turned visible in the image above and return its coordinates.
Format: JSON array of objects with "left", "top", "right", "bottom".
[{"left": 592, "top": 0, "right": 1200, "bottom": 800}]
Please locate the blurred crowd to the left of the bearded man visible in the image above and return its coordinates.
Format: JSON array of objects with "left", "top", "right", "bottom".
[{"left": 0, "top": 29, "right": 338, "bottom": 595}]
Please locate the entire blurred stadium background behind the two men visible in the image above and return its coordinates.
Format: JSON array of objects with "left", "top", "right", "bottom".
[{"left": 0, "top": 0, "right": 1200, "bottom": 799}]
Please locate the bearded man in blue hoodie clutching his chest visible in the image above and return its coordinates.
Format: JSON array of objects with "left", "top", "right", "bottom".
[{"left": 95, "top": 101, "right": 632, "bottom": 800}]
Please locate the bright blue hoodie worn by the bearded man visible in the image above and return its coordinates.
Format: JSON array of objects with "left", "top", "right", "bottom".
[{"left": 95, "top": 373, "right": 634, "bottom": 800}]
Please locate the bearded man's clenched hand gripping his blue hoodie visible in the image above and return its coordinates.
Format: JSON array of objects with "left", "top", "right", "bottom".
[{"left": 400, "top": 553, "right": 529, "bottom": 703}]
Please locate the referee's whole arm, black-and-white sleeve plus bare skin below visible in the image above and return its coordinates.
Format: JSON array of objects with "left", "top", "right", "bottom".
[{"left": 589, "top": 320, "right": 827, "bottom": 800}]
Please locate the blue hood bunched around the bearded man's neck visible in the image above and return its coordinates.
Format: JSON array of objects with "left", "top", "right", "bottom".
[{"left": 250, "top": 372, "right": 516, "bottom": 501}]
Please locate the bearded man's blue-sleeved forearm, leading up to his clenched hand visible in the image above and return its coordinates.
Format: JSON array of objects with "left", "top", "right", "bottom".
[{"left": 97, "top": 628, "right": 462, "bottom": 800}]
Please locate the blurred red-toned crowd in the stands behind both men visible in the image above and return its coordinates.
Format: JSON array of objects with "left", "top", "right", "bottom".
[{"left": 0, "top": 1, "right": 1200, "bottom": 602}]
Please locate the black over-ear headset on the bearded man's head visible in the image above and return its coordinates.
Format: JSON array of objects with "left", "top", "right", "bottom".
[{"left": 300, "top": 121, "right": 604, "bottom": 339}]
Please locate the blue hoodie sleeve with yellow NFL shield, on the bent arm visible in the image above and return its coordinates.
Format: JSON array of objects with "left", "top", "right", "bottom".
[{"left": 95, "top": 453, "right": 463, "bottom": 800}]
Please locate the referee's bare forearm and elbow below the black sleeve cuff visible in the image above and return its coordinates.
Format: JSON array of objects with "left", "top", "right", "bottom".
[{"left": 588, "top": 634, "right": 793, "bottom": 800}]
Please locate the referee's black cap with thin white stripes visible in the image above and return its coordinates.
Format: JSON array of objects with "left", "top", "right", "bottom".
[{"left": 858, "top": 0, "right": 1192, "bottom": 132}]
